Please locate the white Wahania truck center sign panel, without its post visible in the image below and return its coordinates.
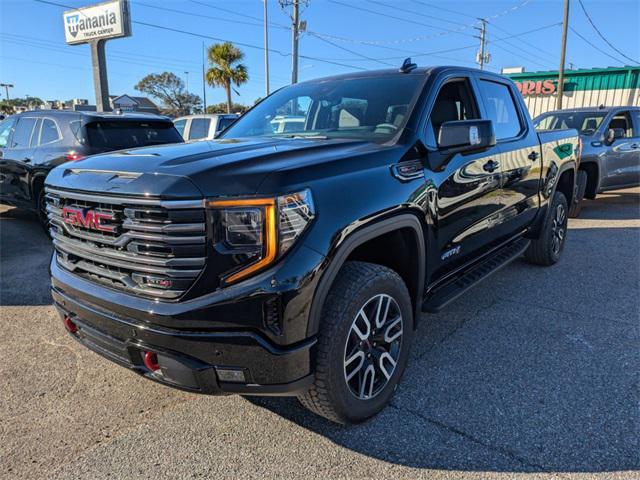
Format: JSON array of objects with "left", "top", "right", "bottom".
[{"left": 63, "top": 0, "right": 131, "bottom": 45}]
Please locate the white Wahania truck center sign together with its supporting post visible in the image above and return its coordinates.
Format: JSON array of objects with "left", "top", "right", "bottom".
[{"left": 63, "top": 0, "right": 131, "bottom": 112}]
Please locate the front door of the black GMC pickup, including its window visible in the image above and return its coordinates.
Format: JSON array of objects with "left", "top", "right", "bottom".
[{"left": 426, "top": 76, "right": 502, "bottom": 283}]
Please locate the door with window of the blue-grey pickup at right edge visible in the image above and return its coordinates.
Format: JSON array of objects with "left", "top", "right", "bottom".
[{"left": 601, "top": 110, "right": 640, "bottom": 188}]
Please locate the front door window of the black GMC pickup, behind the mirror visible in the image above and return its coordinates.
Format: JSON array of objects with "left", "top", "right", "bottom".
[{"left": 430, "top": 80, "right": 479, "bottom": 144}]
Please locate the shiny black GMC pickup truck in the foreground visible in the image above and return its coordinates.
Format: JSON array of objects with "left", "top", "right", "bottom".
[{"left": 46, "top": 62, "right": 578, "bottom": 423}]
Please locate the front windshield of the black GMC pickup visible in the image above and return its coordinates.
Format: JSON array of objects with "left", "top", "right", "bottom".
[{"left": 222, "top": 74, "right": 426, "bottom": 143}]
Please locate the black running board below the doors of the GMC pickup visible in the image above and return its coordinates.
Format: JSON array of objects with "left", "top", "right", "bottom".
[{"left": 422, "top": 238, "right": 530, "bottom": 313}]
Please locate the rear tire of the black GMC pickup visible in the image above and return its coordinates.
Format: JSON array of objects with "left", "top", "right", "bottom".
[{"left": 525, "top": 192, "right": 568, "bottom": 266}]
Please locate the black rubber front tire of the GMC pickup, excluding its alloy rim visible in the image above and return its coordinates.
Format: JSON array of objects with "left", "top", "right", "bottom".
[{"left": 298, "top": 262, "right": 414, "bottom": 423}]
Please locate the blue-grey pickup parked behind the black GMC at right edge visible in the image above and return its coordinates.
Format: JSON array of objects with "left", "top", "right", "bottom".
[{"left": 533, "top": 107, "right": 640, "bottom": 217}]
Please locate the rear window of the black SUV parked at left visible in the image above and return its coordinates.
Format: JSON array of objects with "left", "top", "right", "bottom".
[{"left": 86, "top": 120, "right": 183, "bottom": 150}]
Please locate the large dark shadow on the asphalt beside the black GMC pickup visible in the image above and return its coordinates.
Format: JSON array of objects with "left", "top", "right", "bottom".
[{"left": 247, "top": 220, "right": 640, "bottom": 472}]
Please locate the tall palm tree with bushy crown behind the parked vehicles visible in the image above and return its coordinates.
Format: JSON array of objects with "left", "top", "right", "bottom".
[{"left": 206, "top": 42, "right": 249, "bottom": 113}]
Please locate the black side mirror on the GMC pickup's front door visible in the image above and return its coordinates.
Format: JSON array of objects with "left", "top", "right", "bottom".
[{"left": 438, "top": 120, "right": 496, "bottom": 153}]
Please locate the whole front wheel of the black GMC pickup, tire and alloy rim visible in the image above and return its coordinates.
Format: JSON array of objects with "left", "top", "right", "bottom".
[{"left": 298, "top": 262, "right": 413, "bottom": 423}]
